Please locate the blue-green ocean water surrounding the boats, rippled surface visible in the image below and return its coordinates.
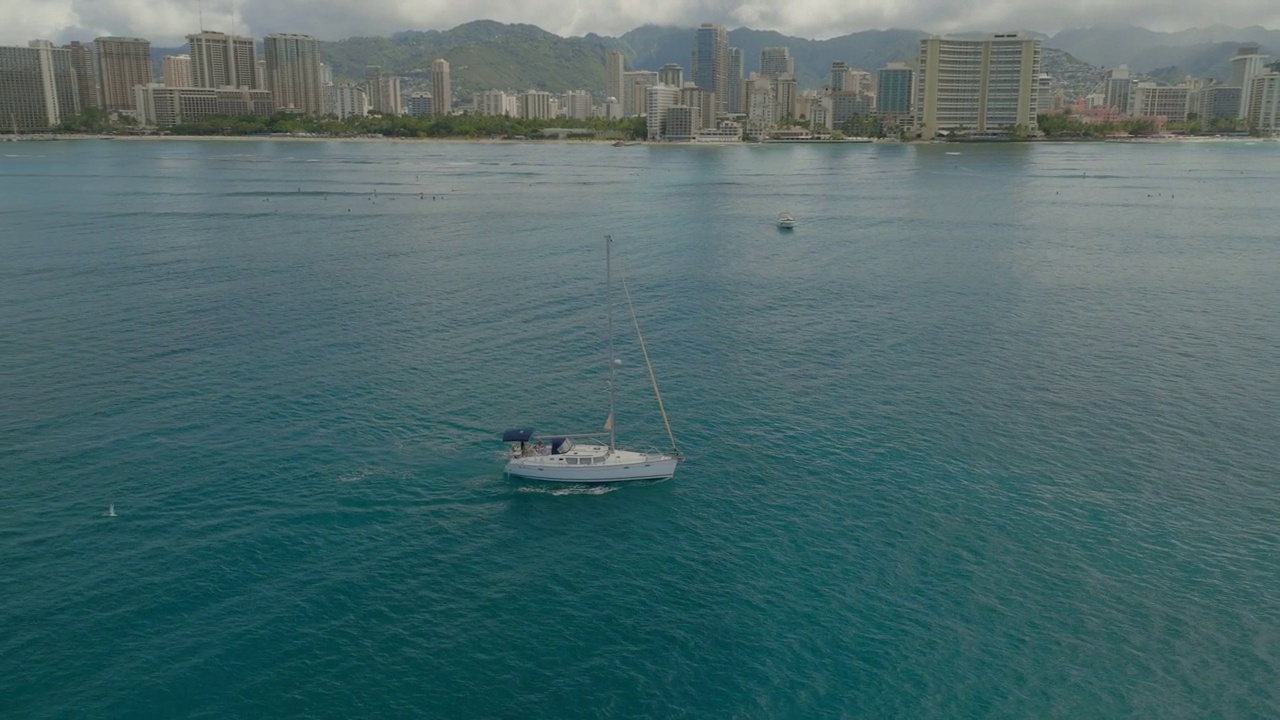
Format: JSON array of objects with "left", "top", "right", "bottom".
[{"left": 0, "top": 141, "right": 1280, "bottom": 719}]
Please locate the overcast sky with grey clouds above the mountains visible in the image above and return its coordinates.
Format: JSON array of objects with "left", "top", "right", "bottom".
[{"left": 0, "top": 0, "right": 1280, "bottom": 46}]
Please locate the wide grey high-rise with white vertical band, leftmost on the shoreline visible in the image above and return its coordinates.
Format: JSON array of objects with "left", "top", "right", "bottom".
[{"left": 0, "top": 40, "right": 81, "bottom": 131}]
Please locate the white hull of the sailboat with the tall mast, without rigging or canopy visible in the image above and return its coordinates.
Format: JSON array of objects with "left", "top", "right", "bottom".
[{"left": 507, "top": 446, "right": 676, "bottom": 483}]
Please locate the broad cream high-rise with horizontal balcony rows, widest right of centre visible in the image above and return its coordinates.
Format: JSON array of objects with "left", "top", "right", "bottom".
[{"left": 915, "top": 32, "right": 1041, "bottom": 138}]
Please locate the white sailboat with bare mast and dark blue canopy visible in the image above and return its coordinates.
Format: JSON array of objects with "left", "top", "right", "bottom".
[{"left": 502, "top": 236, "right": 682, "bottom": 483}]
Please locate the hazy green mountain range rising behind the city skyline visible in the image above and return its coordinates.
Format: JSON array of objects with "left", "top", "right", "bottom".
[{"left": 154, "top": 20, "right": 1280, "bottom": 101}]
